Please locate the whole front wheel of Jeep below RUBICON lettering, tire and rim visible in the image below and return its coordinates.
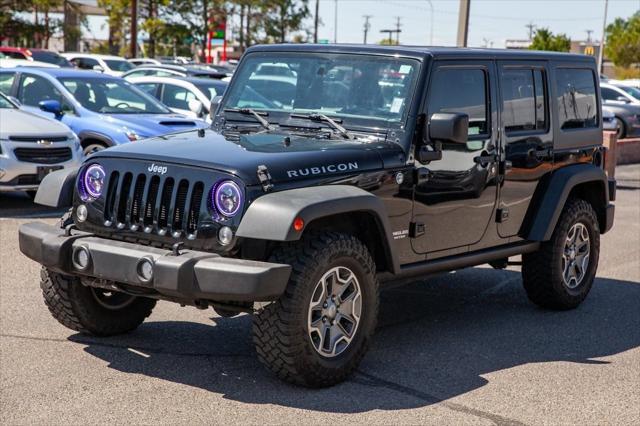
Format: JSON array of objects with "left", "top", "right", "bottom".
[{"left": 253, "top": 233, "right": 378, "bottom": 387}]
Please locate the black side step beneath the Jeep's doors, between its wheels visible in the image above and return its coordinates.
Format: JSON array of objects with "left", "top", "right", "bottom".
[{"left": 380, "top": 241, "right": 540, "bottom": 281}]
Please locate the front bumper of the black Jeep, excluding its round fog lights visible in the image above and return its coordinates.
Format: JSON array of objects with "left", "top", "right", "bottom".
[{"left": 19, "top": 222, "right": 291, "bottom": 304}]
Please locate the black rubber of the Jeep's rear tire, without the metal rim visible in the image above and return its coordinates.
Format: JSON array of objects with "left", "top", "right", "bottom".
[{"left": 522, "top": 198, "right": 600, "bottom": 310}]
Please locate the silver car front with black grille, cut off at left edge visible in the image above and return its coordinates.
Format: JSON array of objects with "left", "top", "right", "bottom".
[{"left": 0, "top": 93, "right": 82, "bottom": 197}]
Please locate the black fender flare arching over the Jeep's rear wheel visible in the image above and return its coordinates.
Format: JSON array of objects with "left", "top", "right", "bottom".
[{"left": 522, "top": 163, "right": 609, "bottom": 241}]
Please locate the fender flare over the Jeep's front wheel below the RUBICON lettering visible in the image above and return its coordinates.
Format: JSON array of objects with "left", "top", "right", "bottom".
[{"left": 236, "top": 185, "right": 400, "bottom": 273}]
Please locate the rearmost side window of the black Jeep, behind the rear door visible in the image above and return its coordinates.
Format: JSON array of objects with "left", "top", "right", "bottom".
[{"left": 556, "top": 68, "right": 598, "bottom": 130}]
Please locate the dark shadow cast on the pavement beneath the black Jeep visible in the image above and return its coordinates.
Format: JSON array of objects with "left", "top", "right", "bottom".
[{"left": 69, "top": 268, "right": 640, "bottom": 413}]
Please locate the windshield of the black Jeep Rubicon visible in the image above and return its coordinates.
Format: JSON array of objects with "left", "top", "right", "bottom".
[{"left": 224, "top": 53, "right": 419, "bottom": 122}]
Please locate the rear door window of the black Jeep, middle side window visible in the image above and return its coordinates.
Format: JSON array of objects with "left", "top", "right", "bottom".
[{"left": 500, "top": 68, "right": 547, "bottom": 133}]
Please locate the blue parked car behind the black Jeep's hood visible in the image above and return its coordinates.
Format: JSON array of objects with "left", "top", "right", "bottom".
[{"left": 0, "top": 68, "right": 208, "bottom": 155}]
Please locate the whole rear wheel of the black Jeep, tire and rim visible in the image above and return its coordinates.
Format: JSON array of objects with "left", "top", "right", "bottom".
[{"left": 522, "top": 199, "right": 600, "bottom": 310}]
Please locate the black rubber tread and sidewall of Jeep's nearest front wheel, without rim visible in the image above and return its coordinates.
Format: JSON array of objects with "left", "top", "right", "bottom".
[{"left": 253, "top": 232, "right": 378, "bottom": 387}]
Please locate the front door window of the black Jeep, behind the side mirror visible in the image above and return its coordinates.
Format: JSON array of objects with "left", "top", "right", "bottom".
[{"left": 428, "top": 68, "right": 489, "bottom": 136}]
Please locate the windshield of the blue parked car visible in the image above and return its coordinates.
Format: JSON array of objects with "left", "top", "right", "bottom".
[{"left": 59, "top": 77, "right": 170, "bottom": 114}]
